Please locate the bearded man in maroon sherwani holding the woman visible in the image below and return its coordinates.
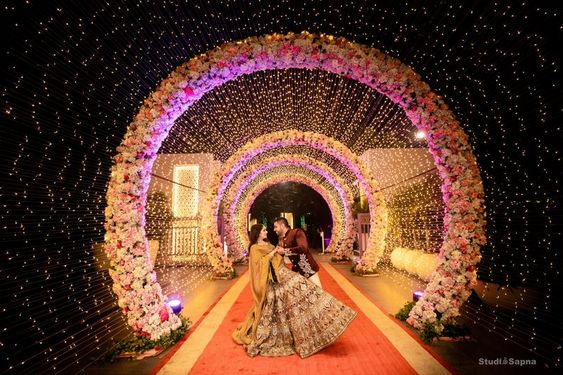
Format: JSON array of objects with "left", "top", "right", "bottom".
[{"left": 274, "top": 217, "right": 322, "bottom": 288}]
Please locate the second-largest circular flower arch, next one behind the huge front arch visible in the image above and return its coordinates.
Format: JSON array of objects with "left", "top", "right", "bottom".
[{"left": 203, "top": 129, "right": 388, "bottom": 272}]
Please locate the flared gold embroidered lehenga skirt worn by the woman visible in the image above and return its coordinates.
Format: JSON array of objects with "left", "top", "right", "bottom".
[{"left": 246, "top": 266, "right": 356, "bottom": 358}]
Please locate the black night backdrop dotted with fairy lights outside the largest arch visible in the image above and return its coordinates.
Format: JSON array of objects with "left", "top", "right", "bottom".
[{"left": 0, "top": 0, "right": 563, "bottom": 373}]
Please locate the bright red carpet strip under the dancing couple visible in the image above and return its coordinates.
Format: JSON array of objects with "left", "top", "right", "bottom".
[{"left": 154, "top": 266, "right": 454, "bottom": 375}]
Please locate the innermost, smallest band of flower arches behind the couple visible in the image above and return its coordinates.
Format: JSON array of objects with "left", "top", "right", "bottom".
[{"left": 225, "top": 161, "right": 354, "bottom": 262}]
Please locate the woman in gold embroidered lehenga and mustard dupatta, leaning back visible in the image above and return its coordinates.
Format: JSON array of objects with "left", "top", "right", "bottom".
[{"left": 232, "top": 224, "right": 356, "bottom": 358}]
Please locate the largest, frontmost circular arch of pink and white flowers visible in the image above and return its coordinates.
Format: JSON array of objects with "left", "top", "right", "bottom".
[{"left": 105, "top": 32, "right": 486, "bottom": 339}]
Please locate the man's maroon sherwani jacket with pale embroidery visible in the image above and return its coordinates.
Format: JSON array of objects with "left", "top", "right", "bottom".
[{"left": 278, "top": 228, "right": 319, "bottom": 278}]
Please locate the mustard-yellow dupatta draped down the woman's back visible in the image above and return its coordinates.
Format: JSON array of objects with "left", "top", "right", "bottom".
[{"left": 232, "top": 244, "right": 283, "bottom": 345}]
